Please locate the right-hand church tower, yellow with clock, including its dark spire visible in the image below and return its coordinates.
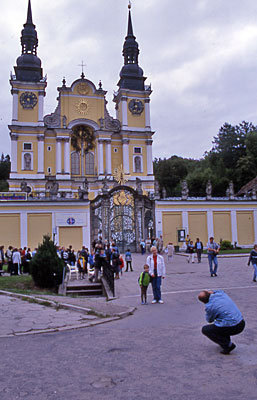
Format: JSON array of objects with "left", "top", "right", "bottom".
[{"left": 114, "top": 5, "right": 154, "bottom": 193}]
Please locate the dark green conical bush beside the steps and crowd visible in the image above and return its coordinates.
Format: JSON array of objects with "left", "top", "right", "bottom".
[{"left": 30, "top": 236, "right": 64, "bottom": 288}]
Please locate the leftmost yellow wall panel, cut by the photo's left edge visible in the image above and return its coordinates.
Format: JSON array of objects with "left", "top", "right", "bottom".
[{"left": 0, "top": 214, "right": 21, "bottom": 251}]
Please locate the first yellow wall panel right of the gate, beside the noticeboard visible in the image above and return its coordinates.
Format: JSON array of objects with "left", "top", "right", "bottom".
[{"left": 162, "top": 212, "right": 182, "bottom": 246}]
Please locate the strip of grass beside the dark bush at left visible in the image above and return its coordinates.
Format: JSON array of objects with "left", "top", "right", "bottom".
[{"left": 0, "top": 268, "right": 56, "bottom": 296}]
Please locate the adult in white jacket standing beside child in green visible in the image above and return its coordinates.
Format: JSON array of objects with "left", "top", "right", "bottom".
[{"left": 146, "top": 246, "right": 166, "bottom": 304}]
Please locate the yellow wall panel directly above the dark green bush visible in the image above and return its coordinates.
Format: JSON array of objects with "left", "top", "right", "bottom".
[{"left": 28, "top": 213, "right": 52, "bottom": 249}]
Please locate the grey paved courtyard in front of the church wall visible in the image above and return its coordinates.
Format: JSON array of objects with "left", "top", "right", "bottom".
[{"left": 0, "top": 255, "right": 257, "bottom": 400}]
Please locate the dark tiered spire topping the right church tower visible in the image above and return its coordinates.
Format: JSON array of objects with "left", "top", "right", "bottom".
[{"left": 118, "top": 2, "right": 146, "bottom": 90}]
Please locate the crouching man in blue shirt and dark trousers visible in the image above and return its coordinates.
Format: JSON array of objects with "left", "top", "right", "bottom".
[{"left": 198, "top": 290, "right": 245, "bottom": 354}]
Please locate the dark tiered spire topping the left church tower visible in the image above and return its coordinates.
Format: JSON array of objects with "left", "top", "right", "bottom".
[{"left": 14, "top": 0, "right": 43, "bottom": 82}]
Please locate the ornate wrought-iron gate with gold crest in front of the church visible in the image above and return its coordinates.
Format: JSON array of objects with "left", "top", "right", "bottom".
[{"left": 91, "top": 186, "right": 154, "bottom": 253}]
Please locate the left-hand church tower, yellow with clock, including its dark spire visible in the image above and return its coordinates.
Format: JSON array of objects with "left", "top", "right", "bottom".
[{"left": 9, "top": 0, "right": 47, "bottom": 191}]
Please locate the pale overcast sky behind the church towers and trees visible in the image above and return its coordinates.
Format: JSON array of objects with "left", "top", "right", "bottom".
[{"left": 0, "top": 0, "right": 257, "bottom": 158}]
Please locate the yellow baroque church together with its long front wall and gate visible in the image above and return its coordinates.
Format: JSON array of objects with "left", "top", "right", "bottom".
[{"left": 0, "top": 0, "right": 257, "bottom": 251}]
